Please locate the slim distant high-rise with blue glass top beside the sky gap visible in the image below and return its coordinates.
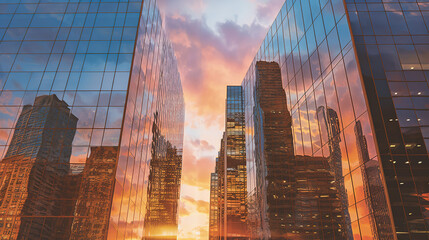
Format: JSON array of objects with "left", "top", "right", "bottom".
[{"left": 215, "top": 86, "right": 249, "bottom": 239}]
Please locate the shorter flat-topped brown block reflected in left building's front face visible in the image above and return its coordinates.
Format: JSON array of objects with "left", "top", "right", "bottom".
[{"left": 70, "top": 147, "right": 118, "bottom": 240}]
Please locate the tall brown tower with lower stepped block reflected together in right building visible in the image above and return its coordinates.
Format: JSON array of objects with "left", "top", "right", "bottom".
[{"left": 249, "top": 61, "right": 346, "bottom": 239}]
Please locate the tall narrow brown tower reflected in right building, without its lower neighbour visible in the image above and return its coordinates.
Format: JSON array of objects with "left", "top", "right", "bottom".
[{"left": 251, "top": 62, "right": 297, "bottom": 239}]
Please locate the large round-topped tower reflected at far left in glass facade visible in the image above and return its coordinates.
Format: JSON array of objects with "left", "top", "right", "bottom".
[{"left": 0, "top": 95, "right": 80, "bottom": 239}]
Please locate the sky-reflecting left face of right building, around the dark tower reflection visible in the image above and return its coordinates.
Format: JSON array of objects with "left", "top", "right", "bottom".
[{"left": 242, "top": 0, "right": 394, "bottom": 239}]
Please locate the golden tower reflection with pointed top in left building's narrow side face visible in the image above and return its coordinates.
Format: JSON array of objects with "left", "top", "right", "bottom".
[{"left": 144, "top": 113, "right": 182, "bottom": 240}]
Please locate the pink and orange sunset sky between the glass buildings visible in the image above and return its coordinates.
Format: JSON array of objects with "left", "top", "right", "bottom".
[{"left": 158, "top": 0, "right": 284, "bottom": 239}]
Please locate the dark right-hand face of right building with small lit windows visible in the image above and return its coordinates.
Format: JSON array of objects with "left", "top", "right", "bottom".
[{"left": 346, "top": 0, "right": 429, "bottom": 239}]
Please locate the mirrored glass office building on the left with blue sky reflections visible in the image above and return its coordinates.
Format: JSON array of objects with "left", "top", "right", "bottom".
[{"left": 0, "top": 0, "right": 184, "bottom": 239}]
